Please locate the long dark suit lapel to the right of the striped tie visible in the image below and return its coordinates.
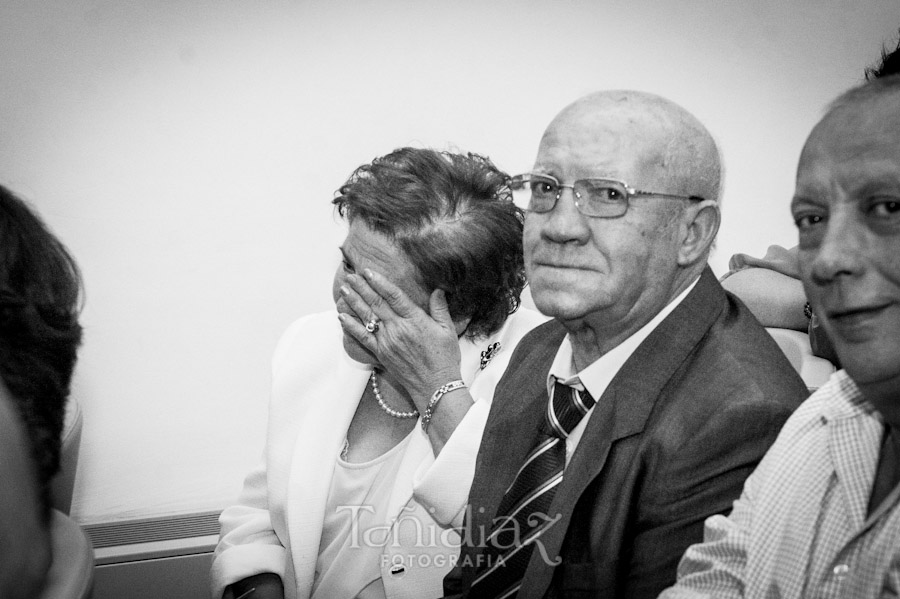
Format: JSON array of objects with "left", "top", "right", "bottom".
[{"left": 522, "top": 267, "right": 724, "bottom": 598}]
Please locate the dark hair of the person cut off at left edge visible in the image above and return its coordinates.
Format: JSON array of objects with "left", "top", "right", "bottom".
[{"left": 0, "top": 185, "right": 81, "bottom": 517}]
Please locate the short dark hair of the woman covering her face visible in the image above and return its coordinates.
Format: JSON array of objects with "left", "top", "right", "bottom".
[{"left": 333, "top": 148, "right": 525, "bottom": 337}]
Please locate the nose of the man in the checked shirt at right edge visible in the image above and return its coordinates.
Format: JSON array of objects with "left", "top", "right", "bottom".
[{"left": 811, "top": 207, "right": 865, "bottom": 285}]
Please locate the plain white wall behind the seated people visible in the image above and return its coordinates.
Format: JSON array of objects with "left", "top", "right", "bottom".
[{"left": 0, "top": 0, "right": 900, "bottom": 523}]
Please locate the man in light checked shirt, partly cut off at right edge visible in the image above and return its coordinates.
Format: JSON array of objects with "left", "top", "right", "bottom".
[{"left": 661, "top": 58, "right": 900, "bottom": 599}]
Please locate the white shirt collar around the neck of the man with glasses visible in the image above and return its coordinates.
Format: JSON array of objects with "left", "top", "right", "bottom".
[{"left": 547, "top": 277, "right": 700, "bottom": 400}]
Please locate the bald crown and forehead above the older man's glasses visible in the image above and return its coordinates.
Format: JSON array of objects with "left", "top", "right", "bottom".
[{"left": 541, "top": 90, "right": 721, "bottom": 201}]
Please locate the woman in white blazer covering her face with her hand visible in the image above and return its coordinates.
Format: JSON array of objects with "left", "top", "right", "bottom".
[{"left": 212, "top": 148, "right": 544, "bottom": 599}]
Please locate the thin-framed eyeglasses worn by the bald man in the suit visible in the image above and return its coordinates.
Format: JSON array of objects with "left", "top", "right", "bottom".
[{"left": 509, "top": 173, "right": 703, "bottom": 218}]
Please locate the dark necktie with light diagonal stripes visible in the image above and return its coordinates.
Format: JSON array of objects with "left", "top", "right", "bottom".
[{"left": 468, "top": 383, "right": 595, "bottom": 599}]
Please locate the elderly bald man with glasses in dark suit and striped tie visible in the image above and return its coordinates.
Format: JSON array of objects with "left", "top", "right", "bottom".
[{"left": 445, "top": 91, "right": 807, "bottom": 598}]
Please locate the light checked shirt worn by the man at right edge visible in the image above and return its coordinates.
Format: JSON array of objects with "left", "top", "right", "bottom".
[{"left": 660, "top": 371, "right": 900, "bottom": 599}]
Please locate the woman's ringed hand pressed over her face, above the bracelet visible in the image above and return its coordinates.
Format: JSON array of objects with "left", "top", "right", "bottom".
[{"left": 338, "top": 269, "right": 460, "bottom": 412}]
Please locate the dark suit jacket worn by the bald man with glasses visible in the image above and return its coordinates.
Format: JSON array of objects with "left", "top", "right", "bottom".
[{"left": 445, "top": 268, "right": 807, "bottom": 599}]
